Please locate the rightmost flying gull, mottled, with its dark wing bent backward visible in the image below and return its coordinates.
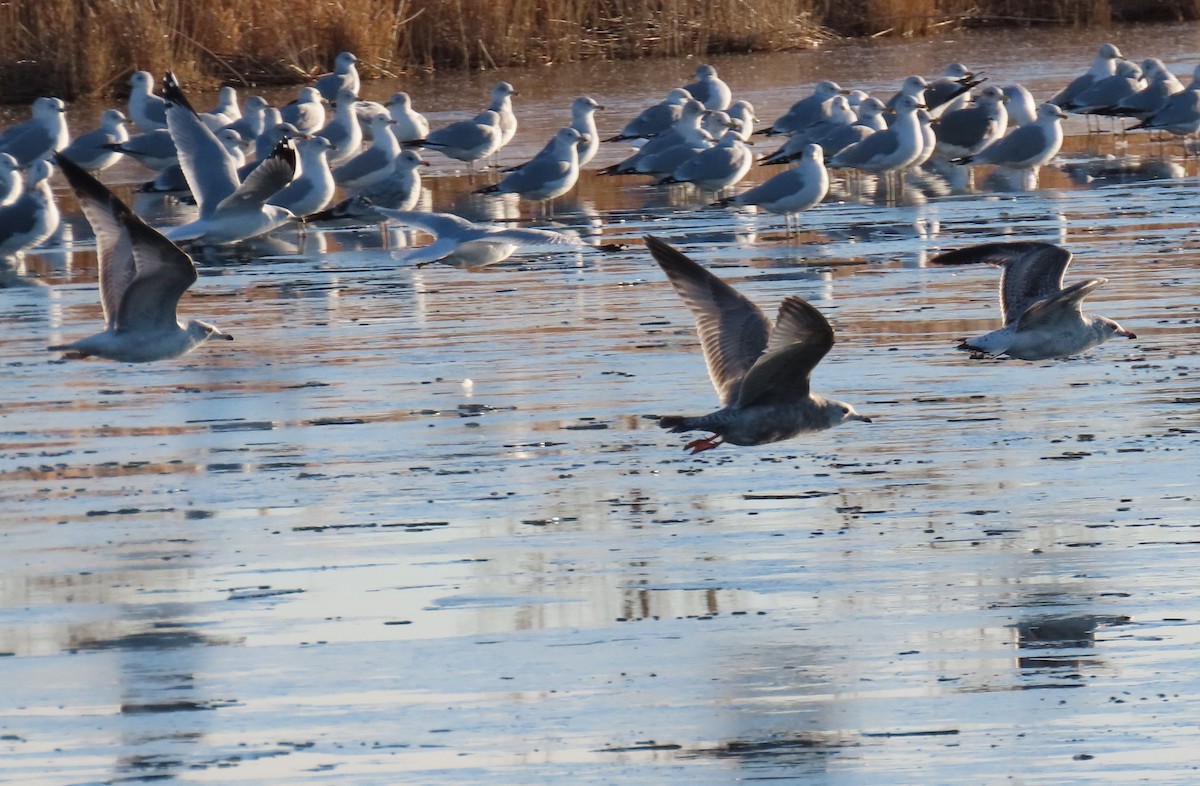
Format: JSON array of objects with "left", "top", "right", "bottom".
[{"left": 930, "top": 241, "right": 1136, "bottom": 360}]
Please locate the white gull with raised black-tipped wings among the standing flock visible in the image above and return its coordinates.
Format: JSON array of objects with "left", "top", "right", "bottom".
[{"left": 163, "top": 71, "right": 296, "bottom": 244}]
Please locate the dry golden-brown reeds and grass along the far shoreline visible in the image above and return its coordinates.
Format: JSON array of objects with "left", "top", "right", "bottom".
[{"left": 0, "top": 0, "right": 1200, "bottom": 103}]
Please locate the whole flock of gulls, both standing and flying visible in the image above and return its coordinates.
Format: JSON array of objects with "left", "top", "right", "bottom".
[{"left": 0, "top": 43, "right": 1161, "bottom": 452}]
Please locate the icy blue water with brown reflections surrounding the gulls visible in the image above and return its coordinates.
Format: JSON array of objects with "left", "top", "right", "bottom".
[{"left": 0, "top": 21, "right": 1200, "bottom": 785}]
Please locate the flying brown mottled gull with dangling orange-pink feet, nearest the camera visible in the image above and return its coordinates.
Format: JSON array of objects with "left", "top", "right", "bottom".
[{"left": 646, "top": 235, "right": 871, "bottom": 454}]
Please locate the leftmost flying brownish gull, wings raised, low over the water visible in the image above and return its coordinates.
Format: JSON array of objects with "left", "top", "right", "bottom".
[{"left": 48, "top": 156, "right": 233, "bottom": 362}]
